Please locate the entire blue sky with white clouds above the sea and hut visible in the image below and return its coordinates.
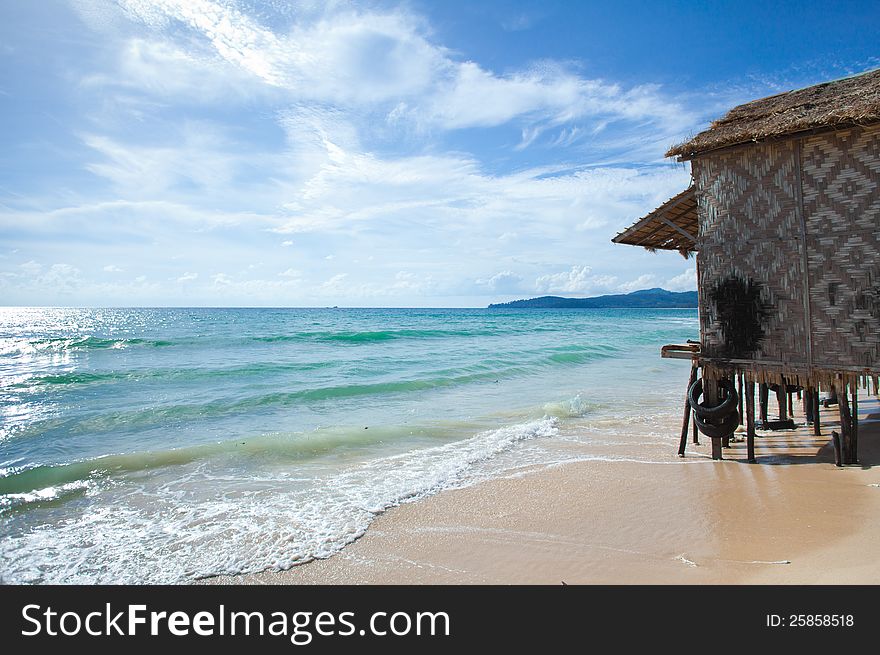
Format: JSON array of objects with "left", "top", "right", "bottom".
[{"left": 0, "top": 0, "right": 880, "bottom": 307}]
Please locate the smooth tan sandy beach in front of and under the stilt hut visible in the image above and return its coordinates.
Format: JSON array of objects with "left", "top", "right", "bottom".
[{"left": 202, "top": 399, "right": 880, "bottom": 585}]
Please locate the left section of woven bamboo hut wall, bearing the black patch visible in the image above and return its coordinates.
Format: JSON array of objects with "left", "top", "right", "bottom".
[{"left": 692, "top": 141, "right": 807, "bottom": 367}]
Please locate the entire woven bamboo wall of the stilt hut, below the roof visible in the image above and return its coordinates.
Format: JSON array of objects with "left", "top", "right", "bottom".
[{"left": 692, "top": 126, "right": 880, "bottom": 381}]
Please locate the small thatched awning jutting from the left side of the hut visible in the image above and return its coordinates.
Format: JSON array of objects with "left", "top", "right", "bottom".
[{"left": 612, "top": 187, "right": 700, "bottom": 257}]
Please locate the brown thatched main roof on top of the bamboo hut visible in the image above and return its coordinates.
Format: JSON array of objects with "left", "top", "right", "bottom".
[{"left": 666, "top": 69, "right": 880, "bottom": 159}]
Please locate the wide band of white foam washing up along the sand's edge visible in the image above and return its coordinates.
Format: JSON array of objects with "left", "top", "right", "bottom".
[{"left": 0, "top": 417, "right": 558, "bottom": 584}]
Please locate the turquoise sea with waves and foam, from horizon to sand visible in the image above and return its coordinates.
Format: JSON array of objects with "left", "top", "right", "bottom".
[{"left": 0, "top": 308, "right": 698, "bottom": 583}]
